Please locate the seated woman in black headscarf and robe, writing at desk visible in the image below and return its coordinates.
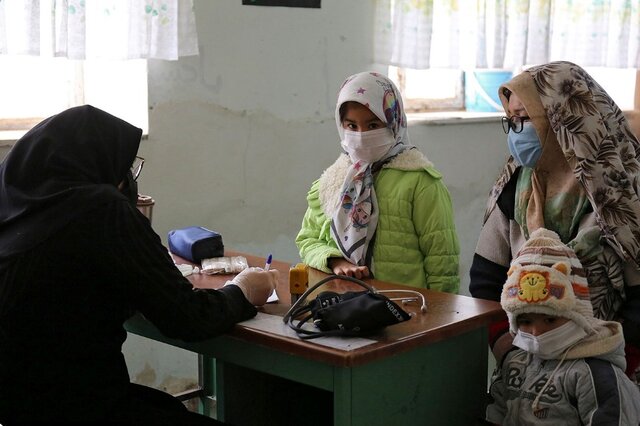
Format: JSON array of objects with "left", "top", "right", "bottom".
[{"left": 0, "top": 105, "right": 278, "bottom": 425}]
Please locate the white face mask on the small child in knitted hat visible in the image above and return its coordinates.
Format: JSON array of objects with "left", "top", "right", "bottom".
[{"left": 513, "top": 321, "right": 587, "bottom": 359}]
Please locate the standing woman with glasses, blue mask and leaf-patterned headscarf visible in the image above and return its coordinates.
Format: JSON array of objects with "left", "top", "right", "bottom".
[{"left": 469, "top": 62, "right": 640, "bottom": 376}]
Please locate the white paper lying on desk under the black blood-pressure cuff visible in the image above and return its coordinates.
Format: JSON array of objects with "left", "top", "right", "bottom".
[{"left": 240, "top": 312, "right": 376, "bottom": 351}]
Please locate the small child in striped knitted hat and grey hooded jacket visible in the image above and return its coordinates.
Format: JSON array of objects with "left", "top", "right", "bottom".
[{"left": 487, "top": 228, "right": 640, "bottom": 425}]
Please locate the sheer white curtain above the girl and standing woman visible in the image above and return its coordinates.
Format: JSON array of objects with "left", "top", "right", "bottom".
[{"left": 374, "top": 0, "right": 640, "bottom": 69}]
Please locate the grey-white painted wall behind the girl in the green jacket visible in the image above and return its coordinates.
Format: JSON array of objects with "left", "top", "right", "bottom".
[{"left": 140, "top": 0, "right": 506, "bottom": 288}]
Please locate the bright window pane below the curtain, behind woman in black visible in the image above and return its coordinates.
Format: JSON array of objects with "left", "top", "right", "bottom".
[{"left": 0, "top": 55, "right": 149, "bottom": 139}]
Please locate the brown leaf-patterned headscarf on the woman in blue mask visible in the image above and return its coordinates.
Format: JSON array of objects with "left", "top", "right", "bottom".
[{"left": 485, "top": 62, "right": 640, "bottom": 265}]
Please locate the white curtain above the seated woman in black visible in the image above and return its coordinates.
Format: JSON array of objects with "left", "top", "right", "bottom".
[{"left": 0, "top": 0, "right": 198, "bottom": 60}]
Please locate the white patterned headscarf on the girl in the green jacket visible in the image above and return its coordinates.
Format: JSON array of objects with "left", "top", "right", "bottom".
[{"left": 331, "top": 72, "right": 414, "bottom": 266}]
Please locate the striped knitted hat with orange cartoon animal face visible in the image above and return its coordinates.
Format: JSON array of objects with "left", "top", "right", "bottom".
[{"left": 500, "top": 228, "right": 596, "bottom": 334}]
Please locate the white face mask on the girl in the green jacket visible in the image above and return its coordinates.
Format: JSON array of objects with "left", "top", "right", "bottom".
[{"left": 341, "top": 127, "right": 396, "bottom": 164}]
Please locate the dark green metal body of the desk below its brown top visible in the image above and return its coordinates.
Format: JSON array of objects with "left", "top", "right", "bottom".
[{"left": 126, "top": 316, "right": 488, "bottom": 426}]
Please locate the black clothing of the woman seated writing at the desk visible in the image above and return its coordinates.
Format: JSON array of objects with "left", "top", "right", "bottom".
[{"left": 0, "top": 106, "right": 256, "bottom": 425}]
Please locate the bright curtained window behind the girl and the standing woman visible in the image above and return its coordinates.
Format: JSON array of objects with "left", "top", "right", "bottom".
[{"left": 373, "top": 0, "right": 640, "bottom": 115}]
